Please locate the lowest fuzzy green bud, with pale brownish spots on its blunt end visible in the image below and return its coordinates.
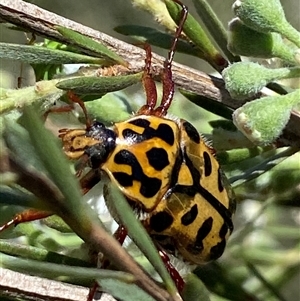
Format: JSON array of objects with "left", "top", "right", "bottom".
[{"left": 233, "top": 90, "right": 300, "bottom": 145}]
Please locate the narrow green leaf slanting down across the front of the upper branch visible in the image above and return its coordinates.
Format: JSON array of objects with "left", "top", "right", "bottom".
[{"left": 56, "top": 26, "right": 127, "bottom": 66}]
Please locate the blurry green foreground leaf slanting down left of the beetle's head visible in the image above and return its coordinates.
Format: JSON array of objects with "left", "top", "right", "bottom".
[{"left": 22, "top": 107, "right": 101, "bottom": 232}]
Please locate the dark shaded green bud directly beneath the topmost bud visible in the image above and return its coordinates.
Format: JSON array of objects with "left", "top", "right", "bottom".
[{"left": 228, "top": 18, "right": 300, "bottom": 65}]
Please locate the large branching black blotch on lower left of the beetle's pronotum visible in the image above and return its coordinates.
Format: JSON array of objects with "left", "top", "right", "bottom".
[{"left": 113, "top": 150, "right": 161, "bottom": 198}]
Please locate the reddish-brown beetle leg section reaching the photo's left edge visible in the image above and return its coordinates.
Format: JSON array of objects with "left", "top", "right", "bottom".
[{"left": 0, "top": 209, "right": 53, "bottom": 232}]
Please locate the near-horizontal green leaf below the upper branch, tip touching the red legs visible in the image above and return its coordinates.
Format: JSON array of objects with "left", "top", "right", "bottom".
[{"left": 56, "top": 72, "right": 143, "bottom": 94}]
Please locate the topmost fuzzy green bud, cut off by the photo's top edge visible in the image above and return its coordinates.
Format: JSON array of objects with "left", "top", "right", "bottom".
[{"left": 233, "top": 0, "right": 300, "bottom": 47}]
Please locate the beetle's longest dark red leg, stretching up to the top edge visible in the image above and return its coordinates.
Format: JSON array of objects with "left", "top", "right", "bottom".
[{"left": 154, "top": 0, "right": 188, "bottom": 116}]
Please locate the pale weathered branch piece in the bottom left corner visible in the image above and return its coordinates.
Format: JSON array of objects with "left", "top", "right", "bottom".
[{"left": 0, "top": 268, "right": 116, "bottom": 301}]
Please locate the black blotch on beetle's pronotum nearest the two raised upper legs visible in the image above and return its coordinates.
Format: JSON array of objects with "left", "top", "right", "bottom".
[{"left": 122, "top": 118, "right": 175, "bottom": 145}]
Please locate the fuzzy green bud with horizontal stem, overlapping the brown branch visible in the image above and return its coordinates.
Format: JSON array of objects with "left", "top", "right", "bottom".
[{"left": 222, "top": 62, "right": 300, "bottom": 99}]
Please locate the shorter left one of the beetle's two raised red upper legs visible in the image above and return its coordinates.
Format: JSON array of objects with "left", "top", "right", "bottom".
[{"left": 137, "top": 44, "right": 157, "bottom": 115}]
